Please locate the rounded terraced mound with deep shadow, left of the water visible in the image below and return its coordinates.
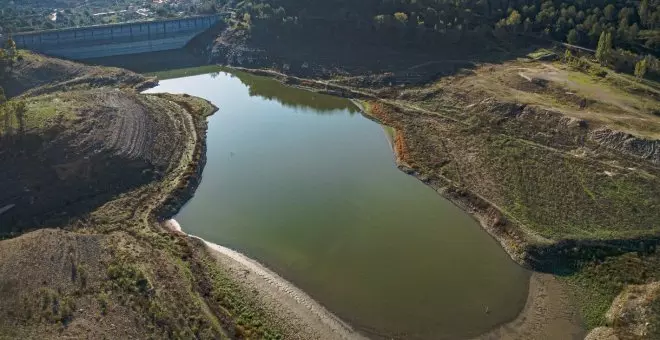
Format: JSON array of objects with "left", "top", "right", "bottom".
[{"left": 0, "top": 57, "right": 193, "bottom": 234}]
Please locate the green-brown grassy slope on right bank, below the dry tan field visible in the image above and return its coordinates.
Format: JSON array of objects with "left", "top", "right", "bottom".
[{"left": 378, "top": 56, "right": 660, "bottom": 240}]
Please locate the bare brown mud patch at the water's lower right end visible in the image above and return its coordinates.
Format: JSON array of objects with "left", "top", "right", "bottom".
[{"left": 475, "top": 273, "right": 586, "bottom": 340}]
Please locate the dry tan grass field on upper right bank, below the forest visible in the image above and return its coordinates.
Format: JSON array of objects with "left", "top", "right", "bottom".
[{"left": 412, "top": 61, "right": 660, "bottom": 139}]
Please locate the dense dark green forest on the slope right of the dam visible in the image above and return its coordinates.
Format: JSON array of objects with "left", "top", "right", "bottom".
[{"left": 233, "top": 0, "right": 660, "bottom": 56}]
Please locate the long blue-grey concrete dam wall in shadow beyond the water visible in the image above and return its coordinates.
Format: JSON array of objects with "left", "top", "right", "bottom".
[{"left": 13, "top": 15, "right": 220, "bottom": 60}]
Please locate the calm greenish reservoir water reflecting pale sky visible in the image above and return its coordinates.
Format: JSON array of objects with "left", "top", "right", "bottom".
[{"left": 143, "top": 68, "right": 529, "bottom": 339}]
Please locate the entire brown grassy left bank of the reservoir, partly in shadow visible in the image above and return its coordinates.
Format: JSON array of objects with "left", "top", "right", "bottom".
[{"left": 0, "top": 52, "right": 294, "bottom": 339}]
